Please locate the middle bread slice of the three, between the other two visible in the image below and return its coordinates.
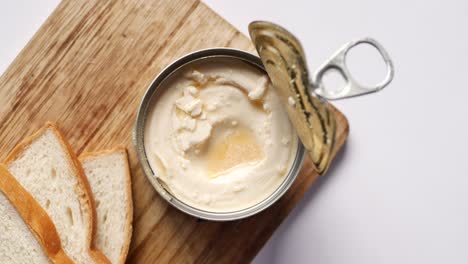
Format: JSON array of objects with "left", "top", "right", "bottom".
[{"left": 5, "top": 123, "right": 108, "bottom": 263}]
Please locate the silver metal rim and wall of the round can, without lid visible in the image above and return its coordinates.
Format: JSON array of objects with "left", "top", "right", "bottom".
[{"left": 132, "top": 48, "right": 306, "bottom": 221}]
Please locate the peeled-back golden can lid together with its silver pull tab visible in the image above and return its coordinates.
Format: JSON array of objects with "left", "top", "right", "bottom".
[{"left": 249, "top": 21, "right": 394, "bottom": 174}]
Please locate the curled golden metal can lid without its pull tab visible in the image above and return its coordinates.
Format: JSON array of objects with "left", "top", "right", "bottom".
[{"left": 249, "top": 21, "right": 336, "bottom": 174}]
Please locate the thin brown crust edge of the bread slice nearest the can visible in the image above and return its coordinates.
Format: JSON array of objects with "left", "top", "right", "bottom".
[{"left": 78, "top": 146, "right": 133, "bottom": 264}]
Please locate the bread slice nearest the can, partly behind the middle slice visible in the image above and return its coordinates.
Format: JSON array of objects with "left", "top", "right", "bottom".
[{"left": 79, "top": 147, "right": 133, "bottom": 263}]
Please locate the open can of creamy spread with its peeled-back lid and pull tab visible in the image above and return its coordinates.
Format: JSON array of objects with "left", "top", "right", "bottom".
[{"left": 134, "top": 21, "right": 394, "bottom": 221}]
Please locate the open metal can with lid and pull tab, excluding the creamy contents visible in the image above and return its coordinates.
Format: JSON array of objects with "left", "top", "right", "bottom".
[{"left": 133, "top": 22, "right": 393, "bottom": 221}]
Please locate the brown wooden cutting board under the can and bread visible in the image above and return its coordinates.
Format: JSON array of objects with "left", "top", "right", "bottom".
[{"left": 0, "top": 0, "right": 348, "bottom": 263}]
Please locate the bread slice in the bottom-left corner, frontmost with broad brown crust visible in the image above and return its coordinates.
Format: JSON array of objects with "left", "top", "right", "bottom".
[{"left": 0, "top": 165, "right": 73, "bottom": 264}]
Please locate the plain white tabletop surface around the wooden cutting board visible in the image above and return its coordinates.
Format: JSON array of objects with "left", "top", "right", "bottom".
[{"left": 0, "top": 0, "right": 468, "bottom": 264}]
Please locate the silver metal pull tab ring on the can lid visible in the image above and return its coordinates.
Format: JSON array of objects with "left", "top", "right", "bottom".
[{"left": 311, "top": 38, "right": 395, "bottom": 100}]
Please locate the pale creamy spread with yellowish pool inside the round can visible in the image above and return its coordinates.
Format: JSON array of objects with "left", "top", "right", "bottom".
[{"left": 144, "top": 59, "right": 298, "bottom": 212}]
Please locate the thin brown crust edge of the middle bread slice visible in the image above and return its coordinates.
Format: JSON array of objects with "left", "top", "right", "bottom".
[{"left": 4, "top": 122, "right": 110, "bottom": 263}]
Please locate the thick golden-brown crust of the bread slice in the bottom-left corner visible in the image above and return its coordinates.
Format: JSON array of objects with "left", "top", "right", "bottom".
[{"left": 0, "top": 164, "right": 73, "bottom": 264}]
